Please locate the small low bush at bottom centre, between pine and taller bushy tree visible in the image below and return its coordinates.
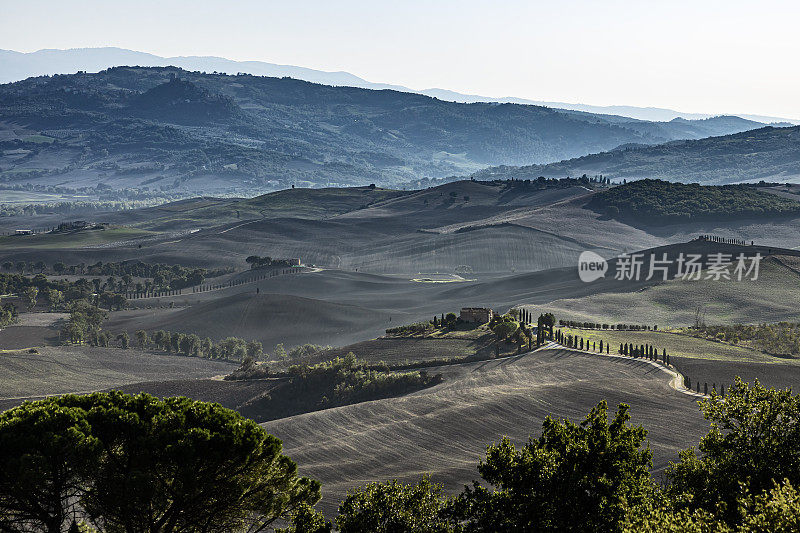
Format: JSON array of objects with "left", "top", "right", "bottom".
[{"left": 336, "top": 477, "right": 454, "bottom": 533}]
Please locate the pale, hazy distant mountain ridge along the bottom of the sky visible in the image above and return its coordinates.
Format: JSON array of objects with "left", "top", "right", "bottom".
[{"left": 0, "top": 47, "right": 800, "bottom": 124}]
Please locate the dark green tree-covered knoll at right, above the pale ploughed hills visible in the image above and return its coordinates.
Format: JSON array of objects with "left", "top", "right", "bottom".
[{"left": 586, "top": 179, "right": 800, "bottom": 224}]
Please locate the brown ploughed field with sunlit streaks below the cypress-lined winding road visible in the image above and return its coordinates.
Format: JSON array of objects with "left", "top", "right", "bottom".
[{"left": 263, "top": 350, "right": 707, "bottom": 514}]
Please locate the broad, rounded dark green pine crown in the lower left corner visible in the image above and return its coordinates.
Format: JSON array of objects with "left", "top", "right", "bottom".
[{"left": 0, "top": 392, "right": 320, "bottom": 533}]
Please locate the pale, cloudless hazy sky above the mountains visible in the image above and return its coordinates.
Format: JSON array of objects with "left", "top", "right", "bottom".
[{"left": 0, "top": 0, "right": 800, "bottom": 118}]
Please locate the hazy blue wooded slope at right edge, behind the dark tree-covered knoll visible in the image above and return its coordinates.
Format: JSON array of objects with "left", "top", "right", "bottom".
[{"left": 473, "top": 126, "right": 800, "bottom": 184}]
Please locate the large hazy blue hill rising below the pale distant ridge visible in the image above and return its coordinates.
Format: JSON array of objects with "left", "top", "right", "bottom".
[{"left": 0, "top": 67, "right": 776, "bottom": 200}]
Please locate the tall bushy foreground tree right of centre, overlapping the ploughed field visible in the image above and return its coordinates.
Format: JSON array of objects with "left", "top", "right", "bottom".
[{"left": 455, "top": 402, "right": 654, "bottom": 532}]
